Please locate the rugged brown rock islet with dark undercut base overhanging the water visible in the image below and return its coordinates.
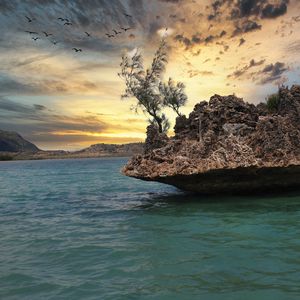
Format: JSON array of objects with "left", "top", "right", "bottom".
[{"left": 122, "top": 85, "right": 300, "bottom": 194}]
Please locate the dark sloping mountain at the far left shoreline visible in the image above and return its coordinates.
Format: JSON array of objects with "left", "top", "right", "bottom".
[{"left": 0, "top": 130, "right": 40, "bottom": 153}]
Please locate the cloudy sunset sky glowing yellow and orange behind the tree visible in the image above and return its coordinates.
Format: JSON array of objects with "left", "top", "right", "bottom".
[{"left": 0, "top": 0, "right": 300, "bottom": 150}]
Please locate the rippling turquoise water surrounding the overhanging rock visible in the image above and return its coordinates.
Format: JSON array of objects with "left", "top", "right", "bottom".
[{"left": 0, "top": 158, "right": 300, "bottom": 300}]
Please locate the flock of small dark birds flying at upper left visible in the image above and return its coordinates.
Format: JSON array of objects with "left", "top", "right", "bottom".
[{"left": 25, "top": 13, "right": 133, "bottom": 52}]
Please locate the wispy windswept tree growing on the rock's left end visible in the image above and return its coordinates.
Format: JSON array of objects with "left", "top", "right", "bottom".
[{"left": 119, "top": 39, "right": 187, "bottom": 132}]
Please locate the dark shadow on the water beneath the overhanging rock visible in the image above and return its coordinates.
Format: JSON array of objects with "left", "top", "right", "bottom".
[{"left": 132, "top": 186, "right": 300, "bottom": 214}]
